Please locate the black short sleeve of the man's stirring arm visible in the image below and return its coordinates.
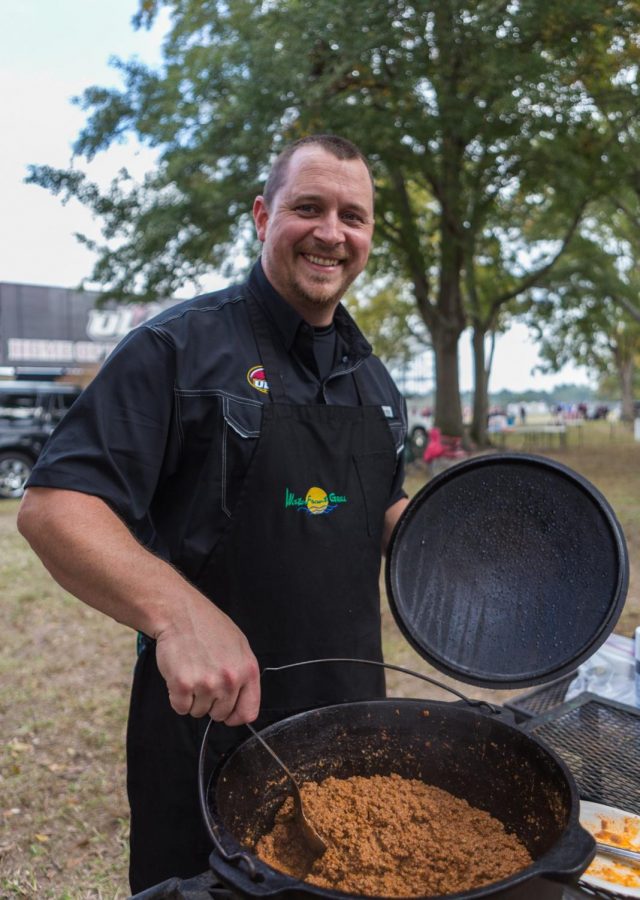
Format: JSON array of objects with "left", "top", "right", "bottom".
[{"left": 27, "top": 326, "right": 175, "bottom": 530}]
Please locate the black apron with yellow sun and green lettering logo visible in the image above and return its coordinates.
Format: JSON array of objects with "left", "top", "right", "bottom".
[{"left": 127, "top": 296, "right": 396, "bottom": 892}]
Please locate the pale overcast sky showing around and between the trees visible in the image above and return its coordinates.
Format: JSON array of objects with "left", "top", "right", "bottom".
[{"left": 0, "top": 0, "right": 590, "bottom": 391}]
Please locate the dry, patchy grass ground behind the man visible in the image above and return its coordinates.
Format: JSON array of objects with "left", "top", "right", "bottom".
[{"left": 0, "top": 422, "right": 640, "bottom": 900}]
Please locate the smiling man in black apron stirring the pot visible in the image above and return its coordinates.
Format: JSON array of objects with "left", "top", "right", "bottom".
[{"left": 19, "top": 135, "right": 407, "bottom": 892}]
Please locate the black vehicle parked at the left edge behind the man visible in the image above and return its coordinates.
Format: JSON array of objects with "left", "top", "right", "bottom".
[{"left": 0, "top": 381, "right": 81, "bottom": 499}]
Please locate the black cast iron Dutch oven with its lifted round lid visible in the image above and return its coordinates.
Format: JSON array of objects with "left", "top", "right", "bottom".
[{"left": 200, "top": 454, "right": 628, "bottom": 900}]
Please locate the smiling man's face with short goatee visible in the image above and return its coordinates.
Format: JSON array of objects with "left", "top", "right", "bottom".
[{"left": 253, "top": 144, "right": 373, "bottom": 325}]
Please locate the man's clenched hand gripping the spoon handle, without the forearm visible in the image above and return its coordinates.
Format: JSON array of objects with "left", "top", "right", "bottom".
[{"left": 156, "top": 598, "right": 260, "bottom": 725}]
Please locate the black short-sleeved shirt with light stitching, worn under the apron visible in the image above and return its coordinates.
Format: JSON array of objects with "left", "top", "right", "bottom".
[{"left": 27, "top": 261, "right": 406, "bottom": 578}]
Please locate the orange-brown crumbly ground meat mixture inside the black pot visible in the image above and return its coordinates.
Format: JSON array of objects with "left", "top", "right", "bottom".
[{"left": 255, "top": 775, "right": 531, "bottom": 897}]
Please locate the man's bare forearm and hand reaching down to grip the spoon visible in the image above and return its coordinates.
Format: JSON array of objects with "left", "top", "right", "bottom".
[{"left": 18, "top": 488, "right": 260, "bottom": 725}]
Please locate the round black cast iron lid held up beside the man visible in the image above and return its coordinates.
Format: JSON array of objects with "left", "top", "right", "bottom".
[{"left": 386, "top": 453, "right": 629, "bottom": 688}]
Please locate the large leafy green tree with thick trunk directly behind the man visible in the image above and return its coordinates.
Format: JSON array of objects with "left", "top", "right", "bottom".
[{"left": 31, "top": 0, "right": 639, "bottom": 434}]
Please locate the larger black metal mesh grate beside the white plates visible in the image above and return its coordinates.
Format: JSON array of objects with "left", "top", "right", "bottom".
[{"left": 522, "top": 692, "right": 640, "bottom": 815}]
